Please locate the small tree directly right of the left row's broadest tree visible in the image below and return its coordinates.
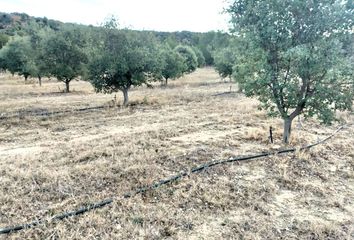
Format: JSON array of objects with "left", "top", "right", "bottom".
[{"left": 160, "top": 47, "right": 186, "bottom": 86}]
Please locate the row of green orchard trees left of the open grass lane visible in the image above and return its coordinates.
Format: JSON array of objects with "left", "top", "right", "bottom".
[{"left": 0, "top": 20, "right": 205, "bottom": 105}]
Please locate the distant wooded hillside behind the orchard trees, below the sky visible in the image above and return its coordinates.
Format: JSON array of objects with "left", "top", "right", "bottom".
[{"left": 0, "top": 13, "right": 236, "bottom": 73}]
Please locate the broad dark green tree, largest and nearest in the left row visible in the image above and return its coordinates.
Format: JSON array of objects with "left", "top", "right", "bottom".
[{"left": 88, "top": 29, "right": 159, "bottom": 106}]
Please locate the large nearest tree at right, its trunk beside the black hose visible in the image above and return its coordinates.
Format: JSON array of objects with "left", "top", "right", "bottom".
[{"left": 228, "top": 0, "right": 354, "bottom": 143}]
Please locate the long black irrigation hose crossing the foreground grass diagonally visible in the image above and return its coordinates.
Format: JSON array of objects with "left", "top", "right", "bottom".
[{"left": 0, "top": 125, "right": 348, "bottom": 234}]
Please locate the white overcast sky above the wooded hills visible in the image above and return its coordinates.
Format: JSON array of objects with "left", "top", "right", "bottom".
[{"left": 0, "top": 0, "right": 228, "bottom": 32}]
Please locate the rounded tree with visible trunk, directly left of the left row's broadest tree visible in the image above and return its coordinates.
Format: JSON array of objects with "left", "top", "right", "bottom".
[{"left": 43, "top": 29, "right": 87, "bottom": 92}]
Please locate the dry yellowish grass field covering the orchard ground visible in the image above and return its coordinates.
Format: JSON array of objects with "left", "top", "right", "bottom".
[{"left": 0, "top": 68, "right": 354, "bottom": 239}]
